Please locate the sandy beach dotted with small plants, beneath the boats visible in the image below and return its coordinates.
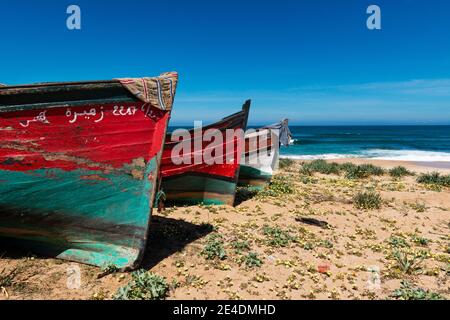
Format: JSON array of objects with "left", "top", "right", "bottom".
[{"left": 0, "top": 159, "right": 450, "bottom": 300}]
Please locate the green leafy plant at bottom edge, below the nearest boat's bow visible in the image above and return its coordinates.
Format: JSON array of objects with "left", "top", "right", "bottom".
[{"left": 114, "top": 270, "right": 169, "bottom": 300}]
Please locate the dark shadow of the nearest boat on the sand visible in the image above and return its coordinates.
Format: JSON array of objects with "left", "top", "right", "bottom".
[{"left": 0, "top": 216, "right": 213, "bottom": 270}]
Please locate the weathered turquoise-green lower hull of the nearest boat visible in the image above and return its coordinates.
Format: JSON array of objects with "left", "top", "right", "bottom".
[{"left": 0, "top": 159, "right": 157, "bottom": 268}]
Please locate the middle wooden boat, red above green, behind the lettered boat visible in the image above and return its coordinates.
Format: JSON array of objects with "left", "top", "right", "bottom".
[{"left": 161, "top": 100, "right": 251, "bottom": 205}]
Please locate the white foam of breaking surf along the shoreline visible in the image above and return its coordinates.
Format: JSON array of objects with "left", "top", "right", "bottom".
[{"left": 281, "top": 149, "right": 450, "bottom": 162}]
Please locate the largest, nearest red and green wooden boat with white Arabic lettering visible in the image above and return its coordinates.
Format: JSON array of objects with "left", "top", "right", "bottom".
[{"left": 0, "top": 73, "right": 178, "bottom": 269}]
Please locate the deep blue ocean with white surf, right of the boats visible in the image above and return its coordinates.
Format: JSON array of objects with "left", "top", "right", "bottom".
[{"left": 281, "top": 126, "right": 450, "bottom": 162}]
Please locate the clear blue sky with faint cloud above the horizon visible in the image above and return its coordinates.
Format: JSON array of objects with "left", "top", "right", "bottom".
[{"left": 0, "top": 0, "right": 450, "bottom": 125}]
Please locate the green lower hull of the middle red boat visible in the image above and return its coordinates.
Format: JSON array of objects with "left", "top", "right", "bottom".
[{"left": 161, "top": 174, "right": 236, "bottom": 205}]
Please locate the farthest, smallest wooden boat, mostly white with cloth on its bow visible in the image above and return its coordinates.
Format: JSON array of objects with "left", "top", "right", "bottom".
[{"left": 238, "top": 119, "right": 291, "bottom": 190}]
